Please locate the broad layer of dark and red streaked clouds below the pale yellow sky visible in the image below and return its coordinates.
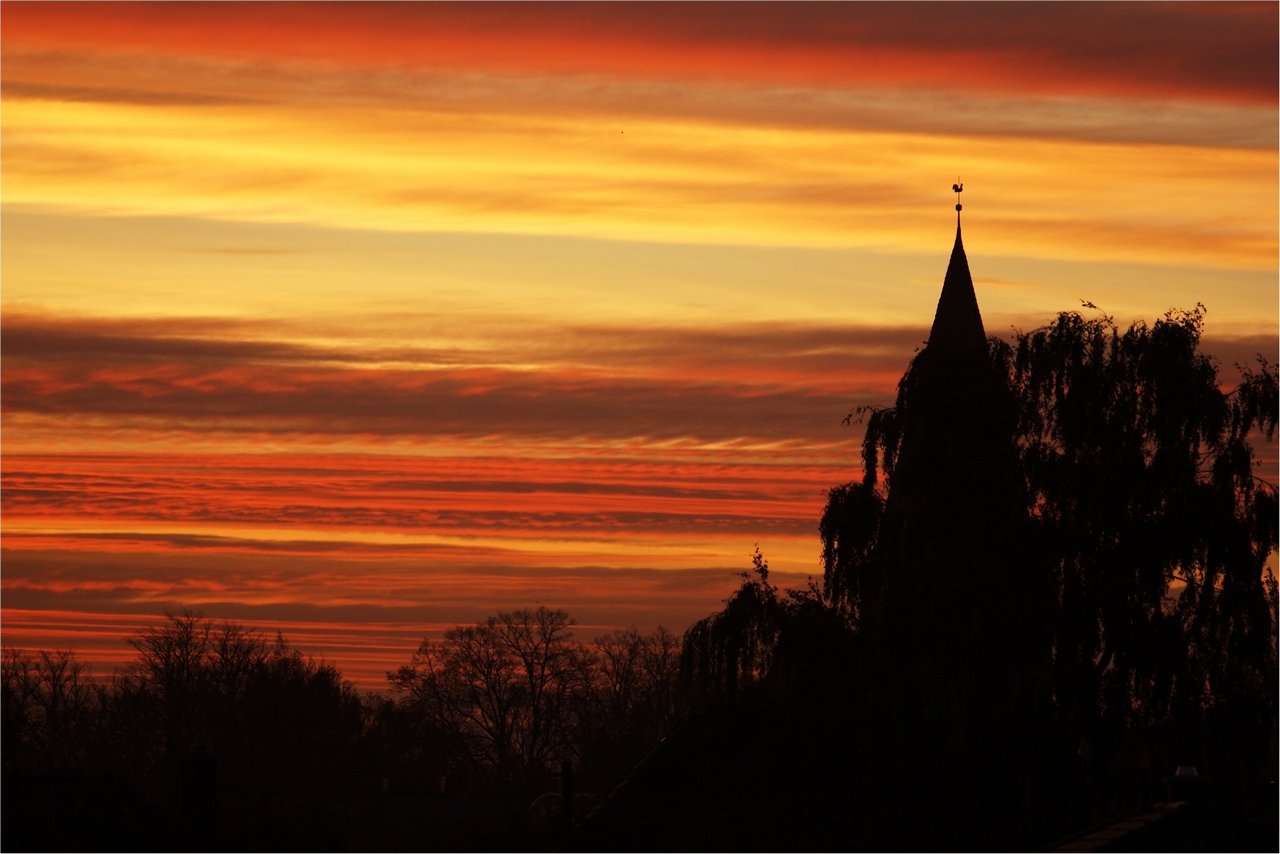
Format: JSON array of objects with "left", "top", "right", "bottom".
[{"left": 0, "top": 312, "right": 870, "bottom": 579}]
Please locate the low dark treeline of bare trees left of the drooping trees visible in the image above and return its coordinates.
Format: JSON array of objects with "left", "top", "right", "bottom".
[{"left": 0, "top": 607, "right": 680, "bottom": 850}]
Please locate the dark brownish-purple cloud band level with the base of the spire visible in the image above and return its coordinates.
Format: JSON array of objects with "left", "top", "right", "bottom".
[{"left": 0, "top": 315, "right": 924, "bottom": 442}]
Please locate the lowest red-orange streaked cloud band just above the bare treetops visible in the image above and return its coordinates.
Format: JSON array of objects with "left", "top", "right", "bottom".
[{"left": 3, "top": 544, "right": 804, "bottom": 690}]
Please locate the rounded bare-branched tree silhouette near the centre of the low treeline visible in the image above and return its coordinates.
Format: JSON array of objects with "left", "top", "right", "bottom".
[{"left": 394, "top": 607, "right": 682, "bottom": 791}]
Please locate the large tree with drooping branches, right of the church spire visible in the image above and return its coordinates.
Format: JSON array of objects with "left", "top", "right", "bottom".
[{"left": 997, "top": 306, "right": 1277, "bottom": 788}]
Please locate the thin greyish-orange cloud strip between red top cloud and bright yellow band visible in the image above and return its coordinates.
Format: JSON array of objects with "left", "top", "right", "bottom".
[{"left": 3, "top": 49, "right": 1277, "bottom": 150}]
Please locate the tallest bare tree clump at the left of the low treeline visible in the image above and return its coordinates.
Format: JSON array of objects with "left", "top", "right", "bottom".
[{"left": 86, "top": 609, "right": 376, "bottom": 799}]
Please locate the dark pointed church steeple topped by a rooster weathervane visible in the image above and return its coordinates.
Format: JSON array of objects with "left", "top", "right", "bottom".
[{"left": 863, "top": 183, "right": 1025, "bottom": 737}]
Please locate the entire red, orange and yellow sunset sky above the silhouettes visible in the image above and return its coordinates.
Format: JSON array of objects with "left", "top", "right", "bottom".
[{"left": 0, "top": 3, "right": 1280, "bottom": 689}]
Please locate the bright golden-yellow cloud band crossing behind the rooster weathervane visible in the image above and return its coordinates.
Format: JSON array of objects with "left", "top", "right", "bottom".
[{"left": 3, "top": 97, "right": 1277, "bottom": 269}]
